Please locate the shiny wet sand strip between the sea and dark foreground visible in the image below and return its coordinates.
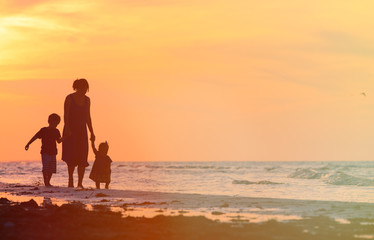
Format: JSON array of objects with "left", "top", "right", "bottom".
[{"left": 0, "top": 183, "right": 374, "bottom": 223}]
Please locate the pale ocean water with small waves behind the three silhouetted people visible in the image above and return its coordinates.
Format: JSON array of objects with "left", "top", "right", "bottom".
[{"left": 0, "top": 161, "right": 374, "bottom": 203}]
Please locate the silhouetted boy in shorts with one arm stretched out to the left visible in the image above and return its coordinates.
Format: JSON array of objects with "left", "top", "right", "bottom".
[{"left": 25, "top": 113, "right": 62, "bottom": 187}]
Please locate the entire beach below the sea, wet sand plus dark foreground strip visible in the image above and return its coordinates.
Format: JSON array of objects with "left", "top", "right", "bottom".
[{"left": 0, "top": 184, "right": 374, "bottom": 240}]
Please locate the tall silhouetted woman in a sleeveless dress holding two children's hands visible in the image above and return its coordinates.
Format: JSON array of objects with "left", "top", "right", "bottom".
[{"left": 62, "top": 78, "right": 95, "bottom": 188}]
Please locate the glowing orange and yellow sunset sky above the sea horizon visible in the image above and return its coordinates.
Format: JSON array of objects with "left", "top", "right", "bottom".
[{"left": 0, "top": 0, "right": 374, "bottom": 161}]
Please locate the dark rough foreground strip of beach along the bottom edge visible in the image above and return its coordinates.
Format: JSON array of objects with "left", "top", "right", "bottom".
[{"left": 0, "top": 198, "right": 374, "bottom": 240}]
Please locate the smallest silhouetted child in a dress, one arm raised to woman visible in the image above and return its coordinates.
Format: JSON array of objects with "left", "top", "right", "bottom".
[{"left": 90, "top": 141, "right": 112, "bottom": 189}]
